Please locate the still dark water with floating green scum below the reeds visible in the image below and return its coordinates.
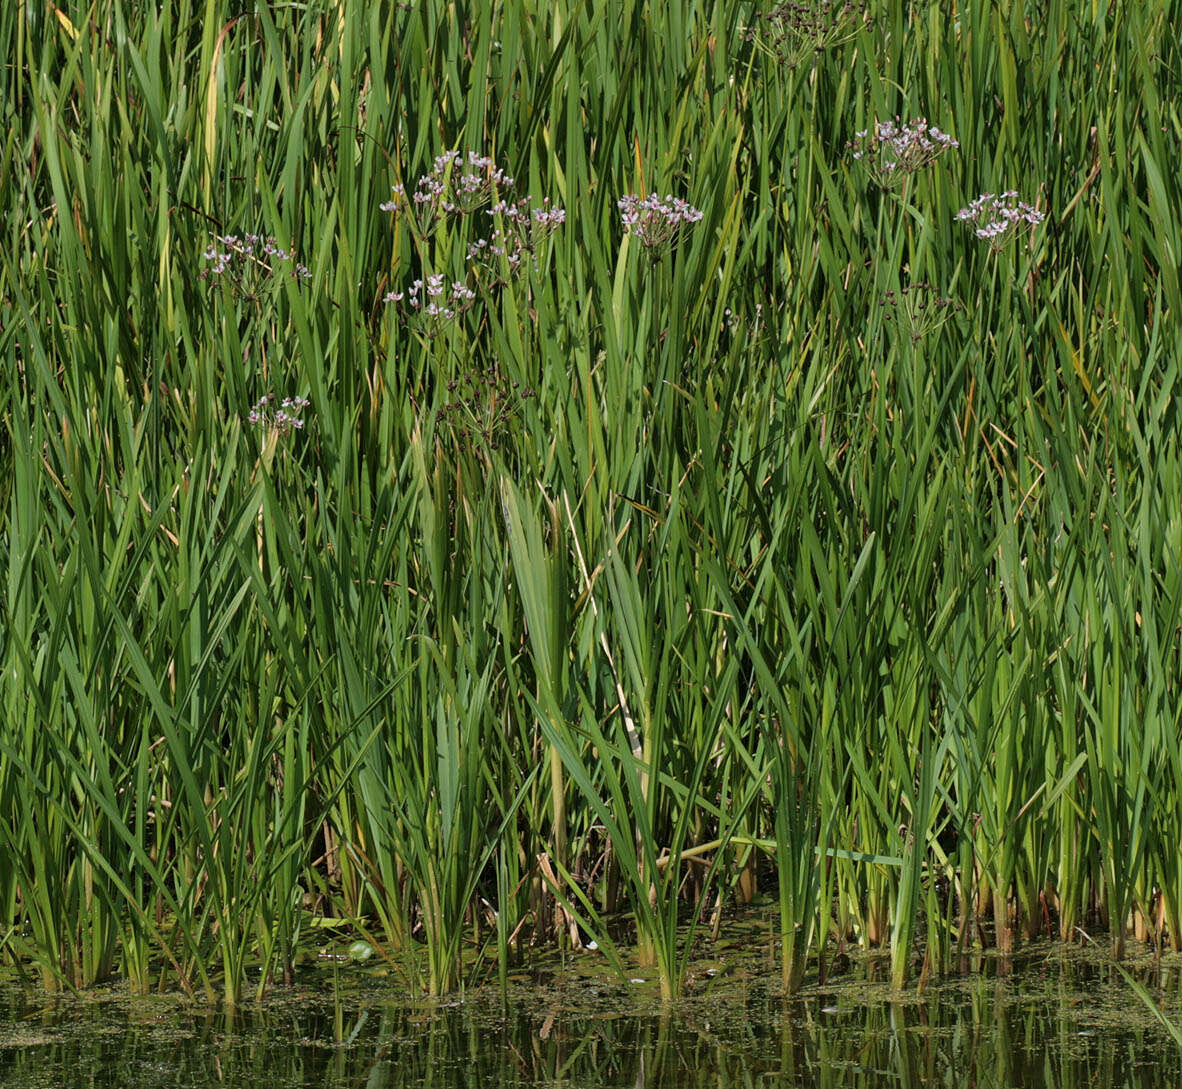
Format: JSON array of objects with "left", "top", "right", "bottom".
[{"left": 0, "top": 946, "right": 1182, "bottom": 1089}]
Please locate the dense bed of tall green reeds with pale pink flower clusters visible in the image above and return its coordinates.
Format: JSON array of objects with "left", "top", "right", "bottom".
[{"left": 0, "top": 0, "right": 1182, "bottom": 1002}]
